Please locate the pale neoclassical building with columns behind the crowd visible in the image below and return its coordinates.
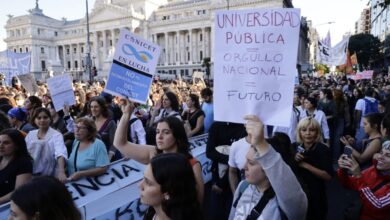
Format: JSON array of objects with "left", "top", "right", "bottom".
[{"left": 5, "top": 0, "right": 308, "bottom": 80}]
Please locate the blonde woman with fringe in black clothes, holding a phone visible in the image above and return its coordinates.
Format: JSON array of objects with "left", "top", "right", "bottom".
[{"left": 293, "top": 117, "right": 333, "bottom": 219}]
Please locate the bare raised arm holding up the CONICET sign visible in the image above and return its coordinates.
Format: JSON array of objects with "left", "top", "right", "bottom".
[{"left": 114, "top": 99, "right": 155, "bottom": 164}]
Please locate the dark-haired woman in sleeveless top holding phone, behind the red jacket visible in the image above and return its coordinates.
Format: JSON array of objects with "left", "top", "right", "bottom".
[{"left": 340, "top": 113, "right": 382, "bottom": 169}]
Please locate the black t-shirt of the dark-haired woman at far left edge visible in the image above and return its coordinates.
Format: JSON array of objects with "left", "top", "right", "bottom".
[{"left": 0, "top": 157, "right": 33, "bottom": 197}]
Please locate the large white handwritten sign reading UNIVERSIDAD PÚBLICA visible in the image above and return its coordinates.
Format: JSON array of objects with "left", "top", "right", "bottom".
[{"left": 214, "top": 8, "right": 300, "bottom": 127}]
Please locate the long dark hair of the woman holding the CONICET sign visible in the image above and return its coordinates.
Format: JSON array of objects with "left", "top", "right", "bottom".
[{"left": 156, "top": 116, "right": 192, "bottom": 158}]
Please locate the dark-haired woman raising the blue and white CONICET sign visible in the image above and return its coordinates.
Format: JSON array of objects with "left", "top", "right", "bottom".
[{"left": 114, "top": 99, "right": 204, "bottom": 202}]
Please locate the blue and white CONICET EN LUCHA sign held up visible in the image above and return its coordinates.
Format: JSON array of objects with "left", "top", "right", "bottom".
[{"left": 104, "top": 29, "right": 160, "bottom": 103}]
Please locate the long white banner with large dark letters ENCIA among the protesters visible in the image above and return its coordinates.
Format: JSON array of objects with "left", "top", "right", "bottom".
[{"left": 0, "top": 134, "right": 211, "bottom": 220}]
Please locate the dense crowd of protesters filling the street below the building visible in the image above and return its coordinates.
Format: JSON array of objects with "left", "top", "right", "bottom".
[{"left": 0, "top": 74, "right": 390, "bottom": 220}]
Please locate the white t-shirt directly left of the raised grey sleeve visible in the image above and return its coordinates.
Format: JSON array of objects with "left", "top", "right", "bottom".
[{"left": 228, "top": 137, "right": 251, "bottom": 170}]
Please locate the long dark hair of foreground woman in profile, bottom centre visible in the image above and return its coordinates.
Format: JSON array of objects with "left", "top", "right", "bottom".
[{"left": 144, "top": 153, "right": 202, "bottom": 220}]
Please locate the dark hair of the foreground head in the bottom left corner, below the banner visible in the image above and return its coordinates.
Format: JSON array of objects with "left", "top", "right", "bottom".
[{"left": 11, "top": 176, "right": 81, "bottom": 220}]
